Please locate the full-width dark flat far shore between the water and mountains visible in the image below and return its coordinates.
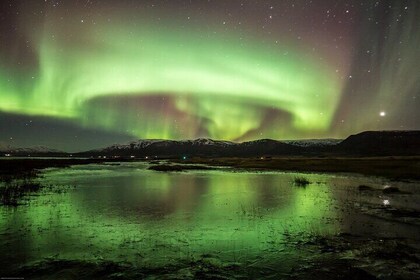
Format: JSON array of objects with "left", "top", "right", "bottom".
[{"left": 0, "top": 156, "right": 420, "bottom": 180}]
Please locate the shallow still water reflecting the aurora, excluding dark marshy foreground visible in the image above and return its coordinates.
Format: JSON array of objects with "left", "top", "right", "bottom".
[{"left": 0, "top": 163, "right": 419, "bottom": 276}]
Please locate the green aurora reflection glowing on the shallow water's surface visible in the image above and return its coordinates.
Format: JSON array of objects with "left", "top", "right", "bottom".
[{"left": 0, "top": 165, "right": 339, "bottom": 267}]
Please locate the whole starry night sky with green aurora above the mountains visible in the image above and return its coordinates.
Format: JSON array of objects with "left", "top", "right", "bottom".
[{"left": 0, "top": 0, "right": 420, "bottom": 151}]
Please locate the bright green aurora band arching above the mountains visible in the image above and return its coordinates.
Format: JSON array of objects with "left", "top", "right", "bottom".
[{"left": 0, "top": 6, "right": 342, "bottom": 140}]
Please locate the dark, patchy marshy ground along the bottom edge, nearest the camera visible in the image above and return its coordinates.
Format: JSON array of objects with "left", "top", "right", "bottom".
[{"left": 9, "top": 234, "right": 420, "bottom": 280}]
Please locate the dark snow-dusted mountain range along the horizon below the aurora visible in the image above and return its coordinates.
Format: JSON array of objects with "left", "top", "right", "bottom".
[{"left": 0, "top": 131, "right": 420, "bottom": 158}]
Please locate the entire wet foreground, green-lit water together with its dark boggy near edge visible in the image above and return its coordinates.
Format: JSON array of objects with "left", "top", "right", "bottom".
[{"left": 0, "top": 163, "right": 420, "bottom": 279}]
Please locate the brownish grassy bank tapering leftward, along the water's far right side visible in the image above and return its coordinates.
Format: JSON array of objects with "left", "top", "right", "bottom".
[{"left": 171, "top": 157, "right": 420, "bottom": 180}]
